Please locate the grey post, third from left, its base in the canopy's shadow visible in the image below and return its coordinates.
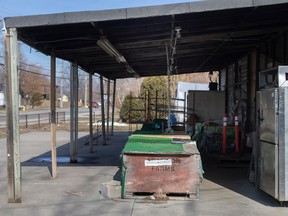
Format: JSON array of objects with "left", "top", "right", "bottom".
[{"left": 70, "top": 63, "right": 78, "bottom": 163}]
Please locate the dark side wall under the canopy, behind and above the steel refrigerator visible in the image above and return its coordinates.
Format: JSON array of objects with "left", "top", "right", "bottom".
[{"left": 220, "top": 32, "right": 288, "bottom": 133}]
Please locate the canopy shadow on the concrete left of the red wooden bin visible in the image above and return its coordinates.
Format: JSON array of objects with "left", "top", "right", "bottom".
[{"left": 21, "top": 132, "right": 129, "bottom": 180}]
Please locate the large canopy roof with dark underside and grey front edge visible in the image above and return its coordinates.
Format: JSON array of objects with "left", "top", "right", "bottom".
[{"left": 5, "top": 0, "right": 288, "bottom": 79}]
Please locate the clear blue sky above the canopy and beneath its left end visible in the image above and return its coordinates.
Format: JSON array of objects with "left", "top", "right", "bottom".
[{"left": 0, "top": 0, "right": 200, "bottom": 68}]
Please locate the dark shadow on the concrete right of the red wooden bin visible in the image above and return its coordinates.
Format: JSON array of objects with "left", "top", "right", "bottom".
[{"left": 202, "top": 155, "right": 281, "bottom": 207}]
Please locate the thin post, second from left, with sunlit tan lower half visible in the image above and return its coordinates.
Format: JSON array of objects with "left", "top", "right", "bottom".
[{"left": 50, "top": 53, "right": 57, "bottom": 178}]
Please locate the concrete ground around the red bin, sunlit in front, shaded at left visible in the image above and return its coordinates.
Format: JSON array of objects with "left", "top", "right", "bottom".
[{"left": 0, "top": 132, "right": 288, "bottom": 216}]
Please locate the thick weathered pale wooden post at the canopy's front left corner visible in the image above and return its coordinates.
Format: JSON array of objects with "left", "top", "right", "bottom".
[{"left": 4, "top": 28, "right": 22, "bottom": 203}]
